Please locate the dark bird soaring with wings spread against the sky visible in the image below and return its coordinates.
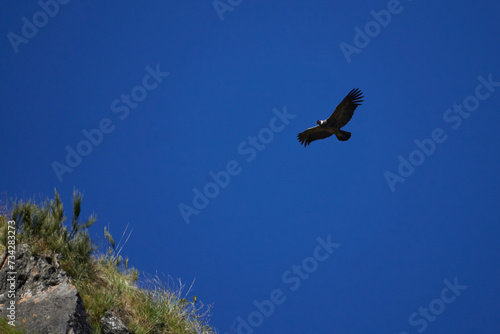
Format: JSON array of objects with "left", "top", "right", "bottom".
[{"left": 297, "top": 88, "right": 363, "bottom": 147}]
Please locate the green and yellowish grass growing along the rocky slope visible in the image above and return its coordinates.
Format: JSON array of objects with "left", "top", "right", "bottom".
[{"left": 0, "top": 191, "right": 216, "bottom": 334}]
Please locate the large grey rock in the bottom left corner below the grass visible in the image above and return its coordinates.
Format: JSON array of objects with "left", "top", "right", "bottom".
[{"left": 0, "top": 244, "right": 90, "bottom": 334}]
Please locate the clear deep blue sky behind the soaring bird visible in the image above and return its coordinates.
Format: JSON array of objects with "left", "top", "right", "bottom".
[{"left": 0, "top": 0, "right": 500, "bottom": 334}]
